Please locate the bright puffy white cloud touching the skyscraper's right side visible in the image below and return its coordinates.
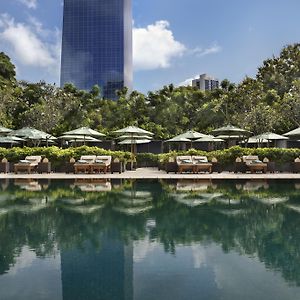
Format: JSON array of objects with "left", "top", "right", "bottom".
[{"left": 133, "top": 21, "right": 187, "bottom": 70}]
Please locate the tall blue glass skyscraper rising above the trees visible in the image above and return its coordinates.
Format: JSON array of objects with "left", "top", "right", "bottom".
[{"left": 61, "top": 0, "right": 133, "bottom": 99}]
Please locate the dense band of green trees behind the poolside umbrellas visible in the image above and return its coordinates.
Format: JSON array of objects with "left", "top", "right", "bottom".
[{"left": 0, "top": 44, "right": 300, "bottom": 138}]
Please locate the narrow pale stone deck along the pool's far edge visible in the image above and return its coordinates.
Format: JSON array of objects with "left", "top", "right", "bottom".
[{"left": 0, "top": 168, "right": 300, "bottom": 180}]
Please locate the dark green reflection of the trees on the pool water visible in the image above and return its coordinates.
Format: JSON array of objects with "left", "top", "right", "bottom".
[{"left": 0, "top": 181, "right": 300, "bottom": 284}]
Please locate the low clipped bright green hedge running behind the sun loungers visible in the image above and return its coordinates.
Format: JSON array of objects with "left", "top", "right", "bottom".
[{"left": 0, "top": 146, "right": 300, "bottom": 167}]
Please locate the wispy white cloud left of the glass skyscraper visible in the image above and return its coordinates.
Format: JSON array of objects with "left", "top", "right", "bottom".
[{"left": 0, "top": 14, "right": 60, "bottom": 72}]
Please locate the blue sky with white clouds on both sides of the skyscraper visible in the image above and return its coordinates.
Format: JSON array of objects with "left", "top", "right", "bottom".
[{"left": 0, "top": 0, "right": 300, "bottom": 92}]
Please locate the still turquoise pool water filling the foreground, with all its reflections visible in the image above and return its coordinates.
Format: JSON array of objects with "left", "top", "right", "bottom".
[{"left": 0, "top": 180, "right": 300, "bottom": 300}]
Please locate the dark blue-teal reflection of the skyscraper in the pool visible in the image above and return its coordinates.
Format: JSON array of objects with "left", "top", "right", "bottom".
[{"left": 61, "top": 235, "right": 133, "bottom": 300}]
